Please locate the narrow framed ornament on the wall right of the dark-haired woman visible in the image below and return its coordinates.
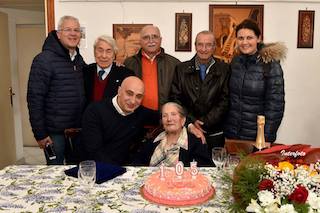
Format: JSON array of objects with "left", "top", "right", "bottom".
[{"left": 297, "top": 10, "right": 315, "bottom": 48}]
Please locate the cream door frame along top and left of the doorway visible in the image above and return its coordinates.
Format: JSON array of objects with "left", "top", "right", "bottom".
[{"left": 0, "top": 8, "right": 44, "bottom": 160}]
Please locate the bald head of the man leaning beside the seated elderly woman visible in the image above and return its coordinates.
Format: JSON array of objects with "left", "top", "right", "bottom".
[{"left": 117, "top": 76, "right": 144, "bottom": 114}]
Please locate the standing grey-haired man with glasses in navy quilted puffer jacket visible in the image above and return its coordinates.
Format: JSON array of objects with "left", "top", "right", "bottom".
[{"left": 27, "top": 16, "right": 85, "bottom": 165}]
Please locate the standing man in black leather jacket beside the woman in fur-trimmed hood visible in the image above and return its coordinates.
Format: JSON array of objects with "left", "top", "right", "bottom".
[{"left": 170, "top": 31, "right": 230, "bottom": 152}]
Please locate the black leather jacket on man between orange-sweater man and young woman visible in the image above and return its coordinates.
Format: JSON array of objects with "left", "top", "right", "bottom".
[{"left": 170, "top": 57, "right": 230, "bottom": 134}]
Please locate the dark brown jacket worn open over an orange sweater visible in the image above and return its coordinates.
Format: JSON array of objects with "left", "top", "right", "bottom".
[{"left": 124, "top": 48, "right": 180, "bottom": 109}]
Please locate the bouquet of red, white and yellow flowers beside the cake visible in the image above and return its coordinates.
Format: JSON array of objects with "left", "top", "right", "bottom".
[{"left": 230, "top": 157, "right": 320, "bottom": 213}]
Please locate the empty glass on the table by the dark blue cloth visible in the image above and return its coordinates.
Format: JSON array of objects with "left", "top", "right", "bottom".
[{"left": 78, "top": 160, "right": 96, "bottom": 190}]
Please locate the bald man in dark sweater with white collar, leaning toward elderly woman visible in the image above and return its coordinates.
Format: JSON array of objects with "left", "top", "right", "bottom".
[{"left": 80, "top": 76, "right": 159, "bottom": 165}]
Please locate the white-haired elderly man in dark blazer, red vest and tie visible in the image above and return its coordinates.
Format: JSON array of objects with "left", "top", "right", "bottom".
[{"left": 84, "top": 35, "right": 134, "bottom": 104}]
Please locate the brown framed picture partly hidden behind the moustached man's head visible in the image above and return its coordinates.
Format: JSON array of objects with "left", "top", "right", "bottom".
[{"left": 113, "top": 24, "right": 151, "bottom": 63}]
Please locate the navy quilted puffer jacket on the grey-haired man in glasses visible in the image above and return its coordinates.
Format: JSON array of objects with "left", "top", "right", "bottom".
[{"left": 27, "top": 31, "right": 85, "bottom": 140}]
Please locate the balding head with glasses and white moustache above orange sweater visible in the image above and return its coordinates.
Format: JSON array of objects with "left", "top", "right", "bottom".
[{"left": 140, "top": 25, "right": 162, "bottom": 57}]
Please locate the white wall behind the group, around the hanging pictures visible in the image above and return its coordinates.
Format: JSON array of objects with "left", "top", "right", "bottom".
[{"left": 55, "top": 0, "right": 320, "bottom": 146}]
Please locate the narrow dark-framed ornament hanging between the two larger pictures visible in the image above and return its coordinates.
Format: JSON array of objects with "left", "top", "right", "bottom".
[{"left": 175, "top": 13, "right": 192, "bottom": 52}]
